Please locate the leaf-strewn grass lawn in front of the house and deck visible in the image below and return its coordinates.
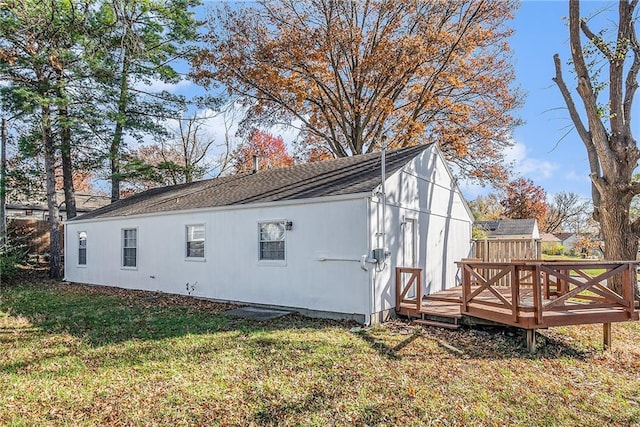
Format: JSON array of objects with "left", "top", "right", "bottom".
[{"left": 0, "top": 270, "right": 640, "bottom": 426}]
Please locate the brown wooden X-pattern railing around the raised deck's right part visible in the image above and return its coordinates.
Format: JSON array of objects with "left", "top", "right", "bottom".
[{"left": 457, "top": 259, "right": 636, "bottom": 328}]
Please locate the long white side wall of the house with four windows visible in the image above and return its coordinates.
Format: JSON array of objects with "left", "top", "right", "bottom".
[{"left": 65, "top": 197, "right": 370, "bottom": 315}]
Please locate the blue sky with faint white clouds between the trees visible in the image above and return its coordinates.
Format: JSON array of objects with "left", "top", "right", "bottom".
[{"left": 171, "top": 0, "right": 624, "bottom": 199}]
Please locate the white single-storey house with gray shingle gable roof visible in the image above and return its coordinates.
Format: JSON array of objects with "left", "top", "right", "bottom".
[{"left": 65, "top": 145, "right": 473, "bottom": 324}]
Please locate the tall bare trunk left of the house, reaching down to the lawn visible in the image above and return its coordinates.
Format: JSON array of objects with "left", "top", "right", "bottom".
[{"left": 42, "top": 106, "right": 63, "bottom": 279}]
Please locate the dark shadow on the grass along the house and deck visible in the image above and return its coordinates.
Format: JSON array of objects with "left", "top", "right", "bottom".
[{"left": 0, "top": 281, "right": 589, "bottom": 368}]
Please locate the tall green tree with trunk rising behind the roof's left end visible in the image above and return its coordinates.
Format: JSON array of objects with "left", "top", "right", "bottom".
[{"left": 89, "top": 0, "right": 200, "bottom": 201}]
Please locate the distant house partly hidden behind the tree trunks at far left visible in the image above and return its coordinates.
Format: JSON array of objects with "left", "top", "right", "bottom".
[{"left": 6, "top": 191, "right": 111, "bottom": 221}]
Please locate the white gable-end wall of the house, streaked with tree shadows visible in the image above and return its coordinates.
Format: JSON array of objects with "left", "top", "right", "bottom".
[{"left": 370, "top": 146, "right": 473, "bottom": 313}]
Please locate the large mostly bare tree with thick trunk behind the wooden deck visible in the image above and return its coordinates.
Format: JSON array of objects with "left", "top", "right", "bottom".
[{"left": 553, "top": 0, "right": 640, "bottom": 296}]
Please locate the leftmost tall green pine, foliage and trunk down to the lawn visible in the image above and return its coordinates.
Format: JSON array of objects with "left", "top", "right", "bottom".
[{"left": 0, "top": 0, "right": 88, "bottom": 278}]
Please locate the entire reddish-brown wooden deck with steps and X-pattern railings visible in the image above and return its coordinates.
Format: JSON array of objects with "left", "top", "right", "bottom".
[{"left": 396, "top": 259, "right": 638, "bottom": 350}]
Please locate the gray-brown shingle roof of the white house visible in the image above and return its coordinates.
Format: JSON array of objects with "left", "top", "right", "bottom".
[{"left": 76, "top": 145, "right": 427, "bottom": 220}]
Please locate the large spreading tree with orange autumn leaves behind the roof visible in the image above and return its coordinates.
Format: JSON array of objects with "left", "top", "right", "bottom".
[{"left": 193, "top": 0, "right": 520, "bottom": 180}]
